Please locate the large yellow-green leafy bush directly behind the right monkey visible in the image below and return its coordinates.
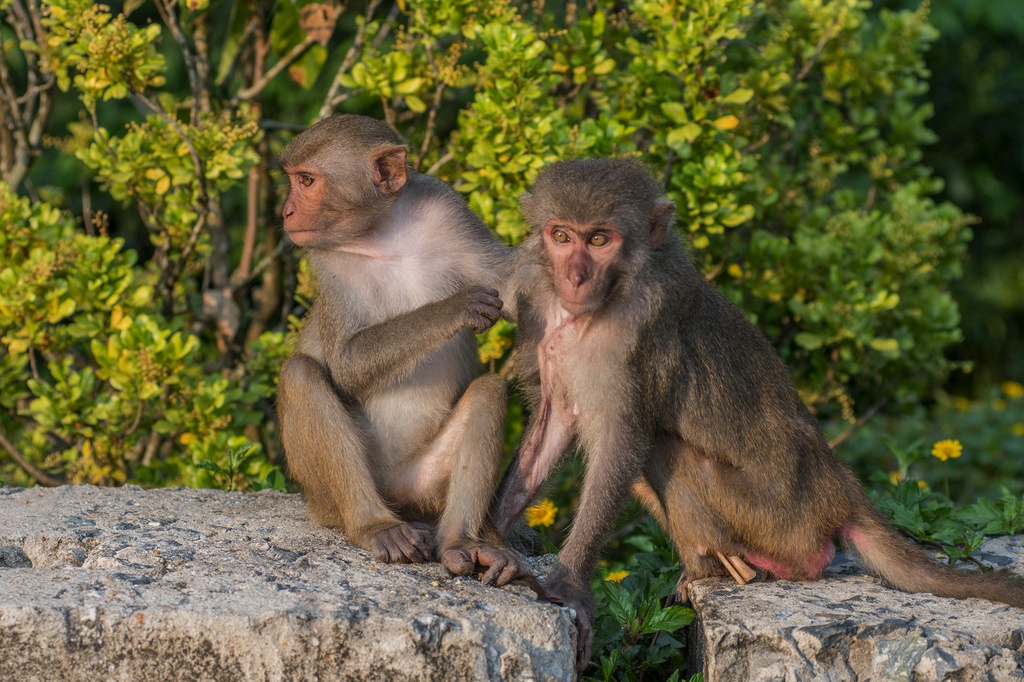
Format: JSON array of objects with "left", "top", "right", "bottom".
[{"left": 452, "top": 0, "right": 970, "bottom": 419}]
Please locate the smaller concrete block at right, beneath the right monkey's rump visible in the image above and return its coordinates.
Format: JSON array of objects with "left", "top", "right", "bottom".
[{"left": 689, "top": 536, "right": 1024, "bottom": 682}]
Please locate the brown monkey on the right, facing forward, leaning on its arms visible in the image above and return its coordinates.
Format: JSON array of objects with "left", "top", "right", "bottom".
[{"left": 494, "top": 159, "right": 1024, "bottom": 667}]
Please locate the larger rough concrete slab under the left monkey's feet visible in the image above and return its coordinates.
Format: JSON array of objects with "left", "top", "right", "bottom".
[{"left": 0, "top": 485, "right": 575, "bottom": 682}]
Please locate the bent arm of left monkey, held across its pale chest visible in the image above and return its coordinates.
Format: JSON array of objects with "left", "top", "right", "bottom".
[{"left": 321, "top": 286, "right": 502, "bottom": 398}]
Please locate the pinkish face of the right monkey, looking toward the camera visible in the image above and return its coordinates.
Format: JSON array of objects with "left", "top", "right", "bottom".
[{"left": 543, "top": 218, "right": 623, "bottom": 315}]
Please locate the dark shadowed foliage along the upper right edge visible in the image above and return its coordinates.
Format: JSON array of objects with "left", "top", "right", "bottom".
[{"left": 880, "top": 0, "right": 1024, "bottom": 394}]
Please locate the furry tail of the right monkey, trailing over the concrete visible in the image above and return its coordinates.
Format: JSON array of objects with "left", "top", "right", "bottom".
[{"left": 840, "top": 499, "right": 1024, "bottom": 608}]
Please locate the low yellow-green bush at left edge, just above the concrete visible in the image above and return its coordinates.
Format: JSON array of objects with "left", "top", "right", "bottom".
[{"left": 0, "top": 183, "right": 284, "bottom": 487}]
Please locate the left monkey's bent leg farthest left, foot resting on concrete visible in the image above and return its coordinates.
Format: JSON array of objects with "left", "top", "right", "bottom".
[{"left": 278, "top": 354, "right": 433, "bottom": 562}]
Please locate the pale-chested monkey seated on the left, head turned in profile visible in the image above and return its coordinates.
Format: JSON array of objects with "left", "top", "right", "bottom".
[{"left": 278, "top": 116, "right": 528, "bottom": 585}]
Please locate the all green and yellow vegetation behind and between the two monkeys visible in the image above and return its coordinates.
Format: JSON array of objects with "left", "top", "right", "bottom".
[{"left": 0, "top": 0, "right": 1024, "bottom": 679}]
